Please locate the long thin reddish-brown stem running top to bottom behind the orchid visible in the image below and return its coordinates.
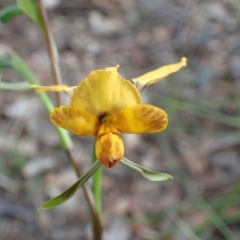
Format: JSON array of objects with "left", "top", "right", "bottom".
[{"left": 37, "top": 0, "right": 102, "bottom": 240}]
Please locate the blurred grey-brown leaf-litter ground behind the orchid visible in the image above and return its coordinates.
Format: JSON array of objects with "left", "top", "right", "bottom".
[{"left": 0, "top": 0, "right": 240, "bottom": 240}]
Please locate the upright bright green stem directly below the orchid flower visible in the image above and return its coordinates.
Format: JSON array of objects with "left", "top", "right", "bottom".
[{"left": 92, "top": 147, "right": 102, "bottom": 218}]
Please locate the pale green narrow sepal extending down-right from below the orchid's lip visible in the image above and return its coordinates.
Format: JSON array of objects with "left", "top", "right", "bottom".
[{"left": 121, "top": 157, "right": 173, "bottom": 181}]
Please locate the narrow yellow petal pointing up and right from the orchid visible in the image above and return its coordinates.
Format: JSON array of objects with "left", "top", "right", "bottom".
[{"left": 132, "top": 57, "right": 187, "bottom": 91}]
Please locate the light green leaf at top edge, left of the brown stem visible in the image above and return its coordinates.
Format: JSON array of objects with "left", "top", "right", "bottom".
[{"left": 16, "top": 0, "right": 43, "bottom": 31}]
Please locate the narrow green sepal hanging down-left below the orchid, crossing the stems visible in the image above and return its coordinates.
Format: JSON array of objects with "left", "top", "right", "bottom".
[{"left": 38, "top": 161, "right": 102, "bottom": 211}]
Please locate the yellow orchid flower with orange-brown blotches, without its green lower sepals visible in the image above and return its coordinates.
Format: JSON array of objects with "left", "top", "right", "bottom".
[{"left": 30, "top": 63, "right": 186, "bottom": 168}]
